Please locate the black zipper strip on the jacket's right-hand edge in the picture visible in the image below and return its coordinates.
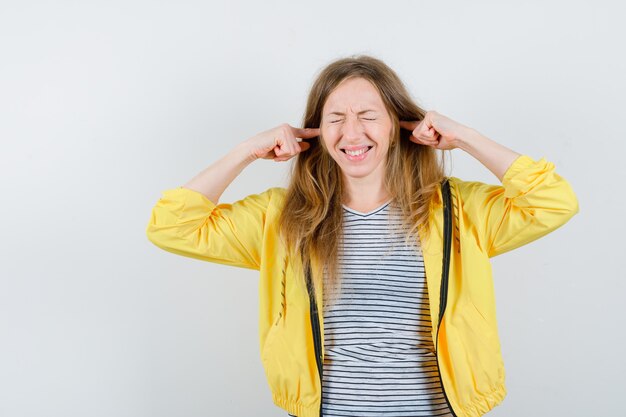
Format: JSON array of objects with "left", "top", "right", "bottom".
[{"left": 435, "top": 178, "right": 457, "bottom": 417}]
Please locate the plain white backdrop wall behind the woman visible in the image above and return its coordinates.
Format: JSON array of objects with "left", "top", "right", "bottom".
[{"left": 0, "top": 0, "right": 626, "bottom": 417}]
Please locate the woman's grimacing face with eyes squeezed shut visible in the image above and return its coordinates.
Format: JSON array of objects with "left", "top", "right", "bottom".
[{"left": 320, "top": 78, "right": 392, "bottom": 181}]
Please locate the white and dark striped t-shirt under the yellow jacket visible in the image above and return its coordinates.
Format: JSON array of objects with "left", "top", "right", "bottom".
[{"left": 289, "top": 201, "right": 452, "bottom": 417}]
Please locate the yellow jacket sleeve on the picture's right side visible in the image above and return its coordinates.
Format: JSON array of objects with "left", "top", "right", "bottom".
[{"left": 459, "top": 155, "right": 579, "bottom": 257}]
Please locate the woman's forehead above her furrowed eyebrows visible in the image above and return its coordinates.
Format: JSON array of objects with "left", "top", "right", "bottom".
[{"left": 324, "top": 78, "right": 384, "bottom": 111}]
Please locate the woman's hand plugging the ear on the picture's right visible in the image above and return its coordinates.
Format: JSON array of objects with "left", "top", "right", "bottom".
[{"left": 400, "top": 111, "right": 469, "bottom": 150}]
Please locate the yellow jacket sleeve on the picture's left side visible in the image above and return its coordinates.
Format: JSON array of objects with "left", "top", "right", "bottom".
[{"left": 146, "top": 187, "right": 272, "bottom": 270}]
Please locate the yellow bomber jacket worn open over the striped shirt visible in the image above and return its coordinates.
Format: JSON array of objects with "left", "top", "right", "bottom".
[{"left": 146, "top": 155, "right": 578, "bottom": 417}]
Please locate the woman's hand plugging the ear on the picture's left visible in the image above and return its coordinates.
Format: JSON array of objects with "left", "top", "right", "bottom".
[{"left": 245, "top": 123, "right": 320, "bottom": 162}]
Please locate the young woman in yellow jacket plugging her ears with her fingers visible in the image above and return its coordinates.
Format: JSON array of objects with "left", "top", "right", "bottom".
[{"left": 147, "top": 56, "right": 578, "bottom": 417}]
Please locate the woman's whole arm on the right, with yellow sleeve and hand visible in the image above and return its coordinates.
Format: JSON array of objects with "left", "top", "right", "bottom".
[{"left": 401, "top": 111, "right": 579, "bottom": 257}]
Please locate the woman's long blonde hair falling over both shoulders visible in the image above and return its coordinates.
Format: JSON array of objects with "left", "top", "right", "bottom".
[{"left": 279, "top": 55, "right": 444, "bottom": 309}]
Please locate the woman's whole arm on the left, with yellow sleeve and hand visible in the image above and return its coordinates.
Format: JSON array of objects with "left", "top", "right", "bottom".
[{"left": 146, "top": 125, "right": 317, "bottom": 269}]
